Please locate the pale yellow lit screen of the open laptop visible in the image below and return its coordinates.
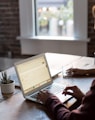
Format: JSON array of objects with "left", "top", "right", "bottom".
[{"left": 15, "top": 56, "right": 51, "bottom": 94}]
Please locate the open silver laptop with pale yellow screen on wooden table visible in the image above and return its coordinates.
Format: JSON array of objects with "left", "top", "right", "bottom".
[{"left": 14, "top": 53, "right": 71, "bottom": 103}]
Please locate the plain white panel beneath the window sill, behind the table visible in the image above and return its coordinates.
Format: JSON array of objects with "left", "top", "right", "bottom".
[{"left": 21, "top": 40, "right": 87, "bottom": 56}]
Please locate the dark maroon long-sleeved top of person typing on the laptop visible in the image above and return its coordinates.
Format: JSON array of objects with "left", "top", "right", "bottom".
[{"left": 46, "top": 80, "right": 95, "bottom": 120}]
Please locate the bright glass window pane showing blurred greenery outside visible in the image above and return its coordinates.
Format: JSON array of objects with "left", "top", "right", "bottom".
[{"left": 36, "top": 0, "right": 74, "bottom": 36}]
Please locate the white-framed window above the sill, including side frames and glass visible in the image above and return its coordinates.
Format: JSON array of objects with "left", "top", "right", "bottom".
[{"left": 19, "top": 0, "right": 88, "bottom": 40}]
